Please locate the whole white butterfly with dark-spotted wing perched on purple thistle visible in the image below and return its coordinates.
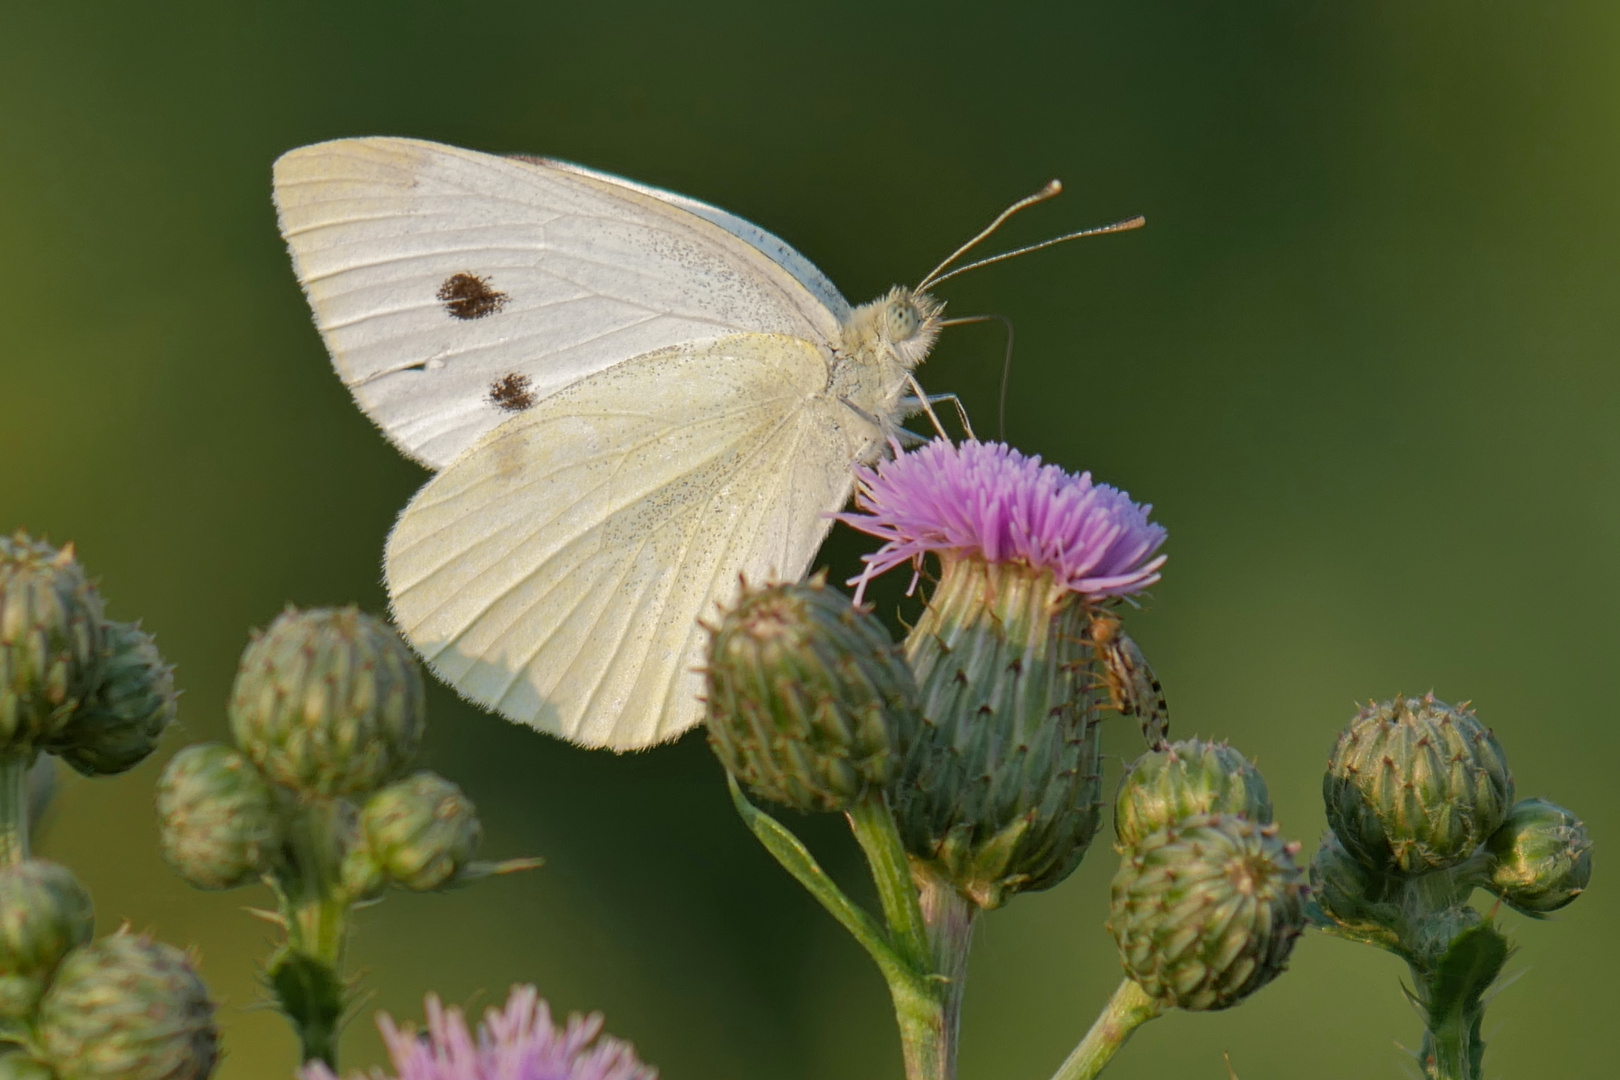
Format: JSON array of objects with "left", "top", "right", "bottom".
[{"left": 274, "top": 138, "right": 1140, "bottom": 750}]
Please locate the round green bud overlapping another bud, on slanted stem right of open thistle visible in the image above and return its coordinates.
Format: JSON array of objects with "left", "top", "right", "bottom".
[{"left": 1108, "top": 814, "right": 1307, "bottom": 1012}]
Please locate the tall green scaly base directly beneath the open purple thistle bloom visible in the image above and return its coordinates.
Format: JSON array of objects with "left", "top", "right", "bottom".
[{"left": 889, "top": 557, "right": 1103, "bottom": 908}]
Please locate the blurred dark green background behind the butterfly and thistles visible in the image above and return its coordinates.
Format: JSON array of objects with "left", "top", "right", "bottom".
[{"left": 0, "top": 0, "right": 1620, "bottom": 1080}]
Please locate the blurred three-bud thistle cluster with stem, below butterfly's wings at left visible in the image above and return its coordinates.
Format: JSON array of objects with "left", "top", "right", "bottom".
[{"left": 157, "top": 607, "right": 538, "bottom": 1062}]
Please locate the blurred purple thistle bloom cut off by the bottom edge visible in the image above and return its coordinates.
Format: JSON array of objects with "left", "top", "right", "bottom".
[{"left": 301, "top": 986, "right": 658, "bottom": 1080}]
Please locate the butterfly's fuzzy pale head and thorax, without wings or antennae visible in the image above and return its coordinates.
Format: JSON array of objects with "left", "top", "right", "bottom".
[{"left": 828, "top": 285, "right": 943, "bottom": 437}]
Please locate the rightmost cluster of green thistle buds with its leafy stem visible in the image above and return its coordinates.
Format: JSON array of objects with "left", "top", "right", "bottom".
[{"left": 1311, "top": 693, "right": 1592, "bottom": 1080}]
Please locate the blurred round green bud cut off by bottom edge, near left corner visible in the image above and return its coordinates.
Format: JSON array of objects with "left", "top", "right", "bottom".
[{"left": 39, "top": 931, "right": 219, "bottom": 1080}]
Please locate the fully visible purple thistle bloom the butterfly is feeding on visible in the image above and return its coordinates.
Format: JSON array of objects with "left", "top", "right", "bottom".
[{"left": 838, "top": 439, "right": 1165, "bottom": 602}]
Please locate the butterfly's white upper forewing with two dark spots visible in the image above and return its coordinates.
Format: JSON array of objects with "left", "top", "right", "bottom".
[{"left": 275, "top": 138, "right": 847, "bottom": 468}]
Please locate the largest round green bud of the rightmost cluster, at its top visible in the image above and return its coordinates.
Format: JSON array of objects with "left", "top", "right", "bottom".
[{"left": 1322, "top": 695, "right": 1513, "bottom": 874}]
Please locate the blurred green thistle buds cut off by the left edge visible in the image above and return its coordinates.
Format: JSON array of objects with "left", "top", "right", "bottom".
[{"left": 0, "top": 533, "right": 219, "bottom": 1080}]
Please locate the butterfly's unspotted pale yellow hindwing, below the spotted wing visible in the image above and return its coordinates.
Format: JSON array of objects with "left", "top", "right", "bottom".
[{"left": 387, "top": 335, "right": 880, "bottom": 750}]
